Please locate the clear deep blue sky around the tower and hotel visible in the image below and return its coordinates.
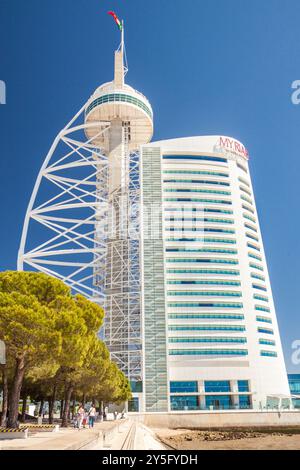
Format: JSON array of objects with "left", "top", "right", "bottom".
[{"left": 0, "top": 0, "right": 300, "bottom": 372}]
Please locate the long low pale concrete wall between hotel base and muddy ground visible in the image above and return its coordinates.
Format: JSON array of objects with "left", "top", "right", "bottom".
[{"left": 129, "top": 410, "right": 300, "bottom": 429}]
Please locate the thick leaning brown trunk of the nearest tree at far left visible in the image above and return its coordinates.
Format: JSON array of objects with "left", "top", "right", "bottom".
[{"left": 7, "top": 354, "right": 25, "bottom": 428}]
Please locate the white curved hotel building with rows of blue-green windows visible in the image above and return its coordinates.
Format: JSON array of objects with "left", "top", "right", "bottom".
[{"left": 143, "top": 138, "right": 287, "bottom": 411}]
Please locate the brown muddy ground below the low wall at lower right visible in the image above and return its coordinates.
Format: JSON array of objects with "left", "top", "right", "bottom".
[{"left": 154, "top": 429, "right": 300, "bottom": 450}]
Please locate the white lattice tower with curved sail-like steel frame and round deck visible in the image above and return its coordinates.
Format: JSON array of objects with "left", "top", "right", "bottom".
[{"left": 18, "top": 28, "right": 153, "bottom": 381}]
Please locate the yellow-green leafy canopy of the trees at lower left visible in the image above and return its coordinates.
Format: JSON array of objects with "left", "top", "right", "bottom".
[{"left": 0, "top": 271, "right": 131, "bottom": 426}]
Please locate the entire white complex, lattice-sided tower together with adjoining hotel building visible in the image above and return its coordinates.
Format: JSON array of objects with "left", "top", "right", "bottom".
[{"left": 18, "top": 20, "right": 290, "bottom": 412}]
